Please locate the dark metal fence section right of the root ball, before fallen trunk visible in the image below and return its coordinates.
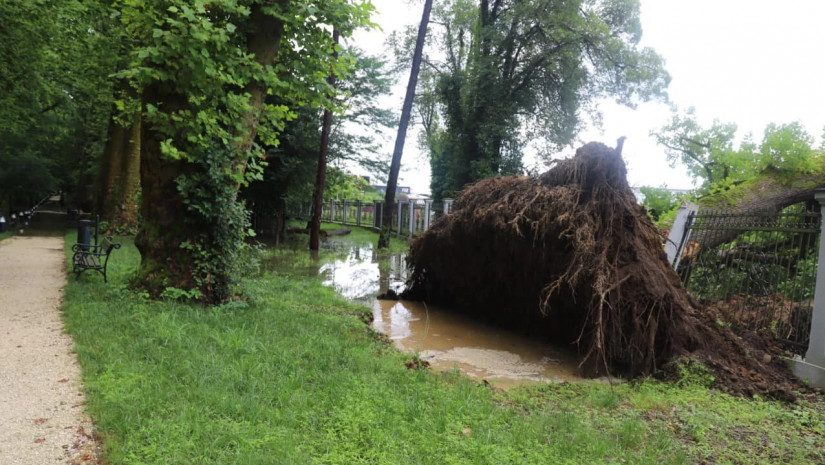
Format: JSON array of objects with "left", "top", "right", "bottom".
[{"left": 671, "top": 204, "right": 821, "bottom": 354}]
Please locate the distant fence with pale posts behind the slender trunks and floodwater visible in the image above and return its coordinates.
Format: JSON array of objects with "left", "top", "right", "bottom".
[{"left": 290, "top": 199, "right": 453, "bottom": 236}]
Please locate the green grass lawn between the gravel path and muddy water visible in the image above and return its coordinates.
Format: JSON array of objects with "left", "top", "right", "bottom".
[{"left": 63, "top": 228, "right": 825, "bottom": 465}]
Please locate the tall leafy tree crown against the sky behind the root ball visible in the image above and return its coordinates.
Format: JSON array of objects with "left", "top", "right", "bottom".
[{"left": 418, "top": 0, "right": 669, "bottom": 198}]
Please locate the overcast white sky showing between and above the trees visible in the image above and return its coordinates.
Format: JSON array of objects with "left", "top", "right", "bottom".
[{"left": 348, "top": 0, "right": 825, "bottom": 192}]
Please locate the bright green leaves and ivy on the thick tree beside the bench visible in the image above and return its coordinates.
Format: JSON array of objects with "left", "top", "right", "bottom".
[{"left": 118, "top": 0, "right": 372, "bottom": 303}]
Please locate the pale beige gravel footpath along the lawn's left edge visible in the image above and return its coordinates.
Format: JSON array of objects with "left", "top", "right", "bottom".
[{"left": 0, "top": 236, "right": 98, "bottom": 465}]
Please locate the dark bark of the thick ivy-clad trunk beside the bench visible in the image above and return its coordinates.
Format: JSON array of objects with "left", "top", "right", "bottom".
[{"left": 135, "top": 0, "right": 286, "bottom": 302}]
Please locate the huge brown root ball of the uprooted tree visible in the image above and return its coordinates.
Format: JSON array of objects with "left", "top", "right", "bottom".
[{"left": 404, "top": 143, "right": 794, "bottom": 397}]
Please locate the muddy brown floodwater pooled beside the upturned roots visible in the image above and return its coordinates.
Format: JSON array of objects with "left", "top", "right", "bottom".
[{"left": 268, "top": 239, "right": 582, "bottom": 388}]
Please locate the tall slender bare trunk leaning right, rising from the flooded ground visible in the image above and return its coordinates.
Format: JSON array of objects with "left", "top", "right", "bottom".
[{"left": 378, "top": 0, "right": 433, "bottom": 249}]
